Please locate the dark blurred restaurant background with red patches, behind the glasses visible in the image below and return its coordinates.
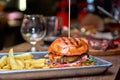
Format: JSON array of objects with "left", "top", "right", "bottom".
[{"left": 0, "top": 0, "right": 120, "bottom": 49}]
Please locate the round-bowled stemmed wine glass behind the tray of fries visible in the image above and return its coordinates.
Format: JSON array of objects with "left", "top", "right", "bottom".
[{"left": 21, "top": 14, "right": 46, "bottom": 52}]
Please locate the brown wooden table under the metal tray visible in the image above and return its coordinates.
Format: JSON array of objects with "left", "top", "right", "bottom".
[{"left": 0, "top": 42, "right": 120, "bottom": 80}]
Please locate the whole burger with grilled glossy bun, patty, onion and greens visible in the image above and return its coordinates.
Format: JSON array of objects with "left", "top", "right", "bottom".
[{"left": 48, "top": 37, "right": 94, "bottom": 68}]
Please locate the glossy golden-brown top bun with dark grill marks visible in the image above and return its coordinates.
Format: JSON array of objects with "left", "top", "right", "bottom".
[{"left": 48, "top": 37, "right": 88, "bottom": 56}]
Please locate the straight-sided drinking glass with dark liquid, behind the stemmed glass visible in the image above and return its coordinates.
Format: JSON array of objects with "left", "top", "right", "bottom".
[{"left": 44, "top": 16, "right": 63, "bottom": 46}]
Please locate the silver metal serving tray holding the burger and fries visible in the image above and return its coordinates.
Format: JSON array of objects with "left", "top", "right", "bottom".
[{"left": 0, "top": 51, "right": 112, "bottom": 80}]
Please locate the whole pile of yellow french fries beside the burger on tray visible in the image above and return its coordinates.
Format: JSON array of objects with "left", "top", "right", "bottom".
[{"left": 0, "top": 49, "right": 49, "bottom": 70}]
